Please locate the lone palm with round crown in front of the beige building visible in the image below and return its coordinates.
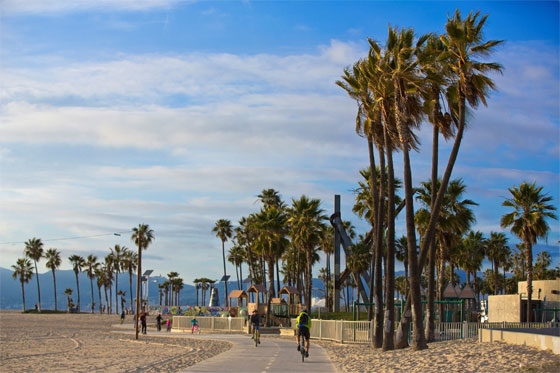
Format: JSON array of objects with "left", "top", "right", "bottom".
[{"left": 501, "top": 182, "right": 557, "bottom": 322}]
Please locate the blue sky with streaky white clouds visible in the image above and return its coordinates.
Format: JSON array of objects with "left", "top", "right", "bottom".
[{"left": 0, "top": 0, "right": 560, "bottom": 283}]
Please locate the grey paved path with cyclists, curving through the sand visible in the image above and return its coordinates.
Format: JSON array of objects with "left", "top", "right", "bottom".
[{"left": 113, "top": 324, "right": 336, "bottom": 373}]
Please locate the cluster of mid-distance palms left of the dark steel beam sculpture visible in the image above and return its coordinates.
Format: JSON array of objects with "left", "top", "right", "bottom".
[{"left": 212, "top": 189, "right": 332, "bottom": 320}]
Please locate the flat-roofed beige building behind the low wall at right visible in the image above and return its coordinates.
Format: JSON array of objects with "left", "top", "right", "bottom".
[{"left": 488, "top": 278, "right": 560, "bottom": 322}]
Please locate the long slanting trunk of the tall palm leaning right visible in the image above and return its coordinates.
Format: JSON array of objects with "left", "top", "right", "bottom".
[{"left": 397, "top": 89, "right": 466, "bottom": 348}]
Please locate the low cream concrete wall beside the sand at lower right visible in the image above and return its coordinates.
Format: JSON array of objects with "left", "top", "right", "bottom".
[{"left": 478, "top": 329, "right": 560, "bottom": 355}]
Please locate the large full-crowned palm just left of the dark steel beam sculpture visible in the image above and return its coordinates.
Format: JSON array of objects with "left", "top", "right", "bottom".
[{"left": 288, "top": 195, "right": 327, "bottom": 307}]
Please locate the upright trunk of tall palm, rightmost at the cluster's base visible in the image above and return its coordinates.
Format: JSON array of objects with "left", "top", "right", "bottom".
[{"left": 426, "top": 123, "right": 440, "bottom": 342}]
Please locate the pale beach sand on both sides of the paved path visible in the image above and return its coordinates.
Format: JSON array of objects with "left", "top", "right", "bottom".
[{"left": 0, "top": 311, "right": 560, "bottom": 373}]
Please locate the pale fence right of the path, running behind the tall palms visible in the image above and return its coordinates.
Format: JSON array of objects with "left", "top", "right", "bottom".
[{"left": 291, "top": 319, "right": 560, "bottom": 343}]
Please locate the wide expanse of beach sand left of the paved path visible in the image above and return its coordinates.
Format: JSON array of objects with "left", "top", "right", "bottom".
[{"left": 0, "top": 311, "right": 231, "bottom": 372}]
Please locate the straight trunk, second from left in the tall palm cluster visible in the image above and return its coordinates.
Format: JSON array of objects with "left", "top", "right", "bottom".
[{"left": 382, "top": 128, "right": 395, "bottom": 351}]
